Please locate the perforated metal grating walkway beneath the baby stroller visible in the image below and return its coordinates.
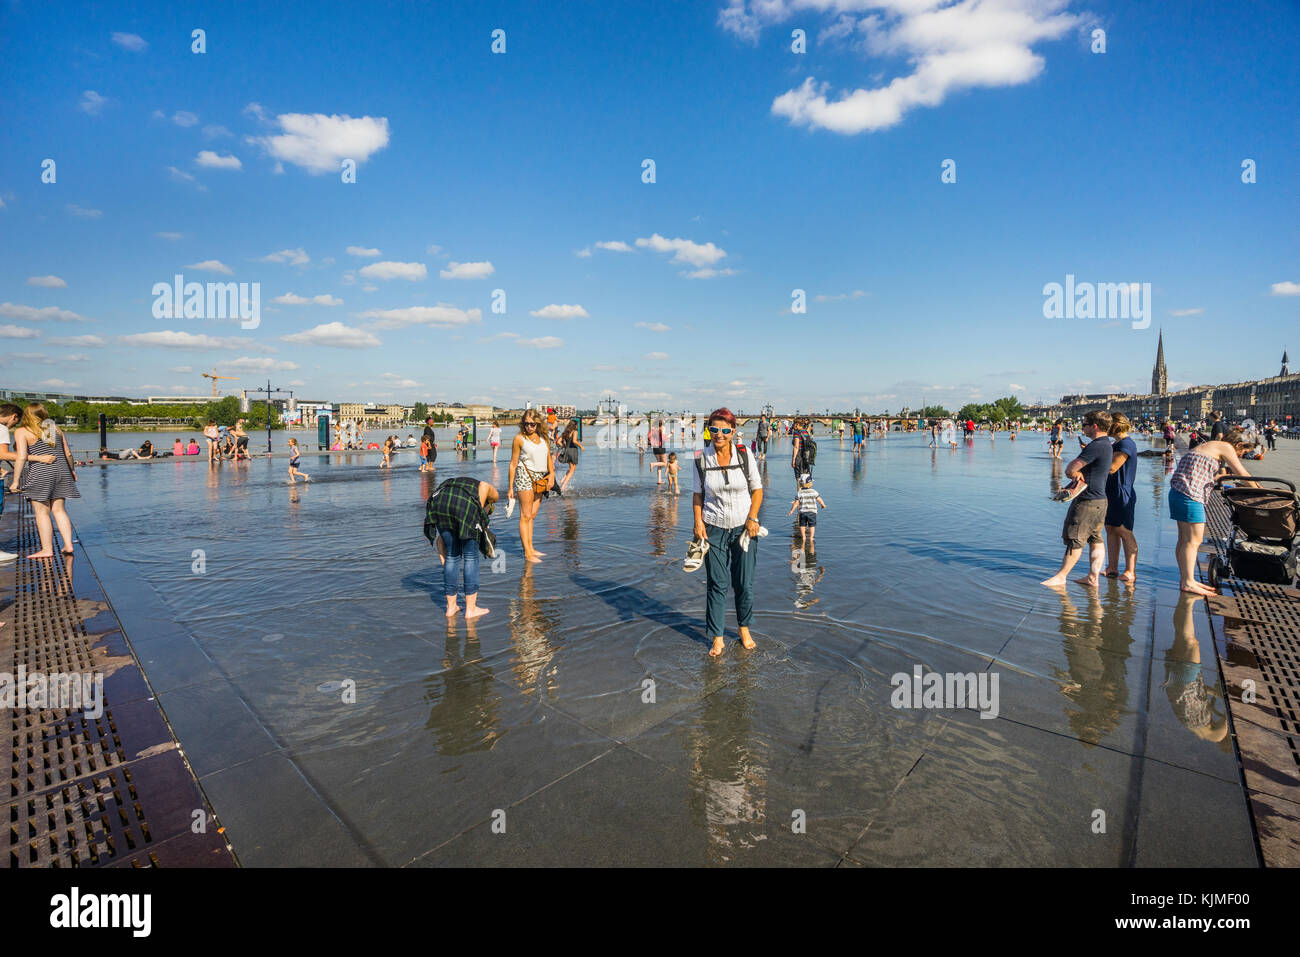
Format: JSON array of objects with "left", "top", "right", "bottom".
[{"left": 1201, "top": 492, "right": 1300, "bottom": 867}]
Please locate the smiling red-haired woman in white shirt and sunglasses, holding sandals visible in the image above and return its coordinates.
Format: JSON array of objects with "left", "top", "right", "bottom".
[{"left": 684, "top": 408, "right": 763, "bottom": 658}]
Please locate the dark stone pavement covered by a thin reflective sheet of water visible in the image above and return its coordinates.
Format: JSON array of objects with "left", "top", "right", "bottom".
[{"left": 58, "top": 433, "right": 1257, "bottom": 866}]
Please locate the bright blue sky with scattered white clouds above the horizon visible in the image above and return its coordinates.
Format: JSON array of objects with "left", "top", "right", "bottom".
[{"left": 0, "top": 0, "right": 1300, "bottom": 411}]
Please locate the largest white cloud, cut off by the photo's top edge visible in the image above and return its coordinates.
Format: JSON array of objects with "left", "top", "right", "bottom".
[{"left": 759, "top": 0, "right": 1084, "bottom": 135}]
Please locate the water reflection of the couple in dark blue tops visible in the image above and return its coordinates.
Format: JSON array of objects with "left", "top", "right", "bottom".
[{"left": 1054, "top": 580, "right": 1138, "bottom": 745}]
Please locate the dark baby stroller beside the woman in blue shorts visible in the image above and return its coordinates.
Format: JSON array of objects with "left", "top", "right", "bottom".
[{"left": 1209, "top": 475, "right": 1300, "bottom": 588}]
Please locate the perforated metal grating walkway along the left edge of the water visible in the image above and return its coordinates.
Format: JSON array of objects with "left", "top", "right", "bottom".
[{"left": 0, "top": 495, "right": 234, "bottom": 869}]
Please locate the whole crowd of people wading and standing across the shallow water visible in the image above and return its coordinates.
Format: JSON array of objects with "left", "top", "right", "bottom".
[{"left": 0, "top": 403, "right": 1282, "bottom": 657}]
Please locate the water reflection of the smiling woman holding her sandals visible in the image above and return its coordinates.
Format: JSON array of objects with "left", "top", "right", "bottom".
[{"left": 686, "top": 658, "right": 767, "bottom": 865}]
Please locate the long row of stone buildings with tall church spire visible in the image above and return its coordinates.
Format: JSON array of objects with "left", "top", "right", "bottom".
[{"left": 1026, "top": 335, "right": 1300, "bottom": 426}]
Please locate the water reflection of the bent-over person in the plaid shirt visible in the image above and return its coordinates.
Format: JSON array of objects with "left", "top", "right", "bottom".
[{"left": 424, "top": 618, "right": 504, "bottom": 754}]
